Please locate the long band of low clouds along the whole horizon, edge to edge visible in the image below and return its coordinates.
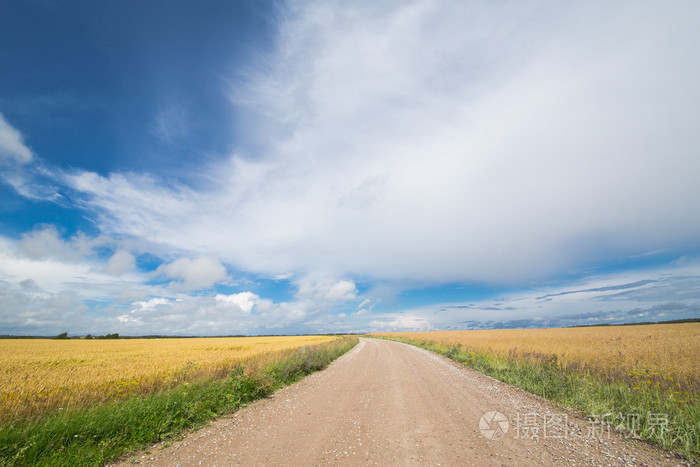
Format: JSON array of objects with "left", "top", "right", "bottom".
[{"left": 0, "top": 227, "right": 700, "bottom": 335}]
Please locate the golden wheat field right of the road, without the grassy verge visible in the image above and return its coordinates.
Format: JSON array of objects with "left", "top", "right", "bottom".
[{"left": 377, "top": 323, "right": 700, "bottom": 390}]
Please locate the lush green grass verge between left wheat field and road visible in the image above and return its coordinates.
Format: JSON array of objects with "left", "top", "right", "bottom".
[{"left": 0, "top": 337, "right": 358, "bottom": 466}]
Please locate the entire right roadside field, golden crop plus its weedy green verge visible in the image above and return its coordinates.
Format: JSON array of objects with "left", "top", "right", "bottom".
[{"left": 374, "top": 323, "right": 700, "bottom": 461}]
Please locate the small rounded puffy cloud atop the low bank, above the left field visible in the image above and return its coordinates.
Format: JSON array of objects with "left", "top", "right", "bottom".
[{"left": 155, "top": 255, "right": 226, "bottom": 290}]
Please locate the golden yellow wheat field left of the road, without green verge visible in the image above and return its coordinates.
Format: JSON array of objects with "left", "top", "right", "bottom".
[{"left": 0, "top": 336, "right": 334, "bottom": 419}]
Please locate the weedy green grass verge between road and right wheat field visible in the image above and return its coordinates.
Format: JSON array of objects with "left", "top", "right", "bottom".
[{"left": 380, "top": 336, "right": 700, "bottom": 463}]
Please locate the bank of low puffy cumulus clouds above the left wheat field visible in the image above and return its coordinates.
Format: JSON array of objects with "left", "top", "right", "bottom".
[{"left": 0, "top": 226, "right": 366, "bottom": 335}]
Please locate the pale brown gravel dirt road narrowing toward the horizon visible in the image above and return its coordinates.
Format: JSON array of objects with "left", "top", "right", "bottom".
[{"left": 119, "top": 339, "right": 685, "bottom": 466}]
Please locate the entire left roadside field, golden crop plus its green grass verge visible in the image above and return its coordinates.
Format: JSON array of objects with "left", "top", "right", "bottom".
[{"left": 0, "top": 336, "right": 358, "bottom": 466}]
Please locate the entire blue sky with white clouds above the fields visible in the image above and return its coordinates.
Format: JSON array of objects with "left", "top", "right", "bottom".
[{"left": 0, "top": 0, "right": 700, "bottom": 336}]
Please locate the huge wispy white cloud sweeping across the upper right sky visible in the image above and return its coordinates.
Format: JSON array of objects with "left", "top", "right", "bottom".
[{"left": 50, "top": 0, "right": 700, "bottom": 287}]
